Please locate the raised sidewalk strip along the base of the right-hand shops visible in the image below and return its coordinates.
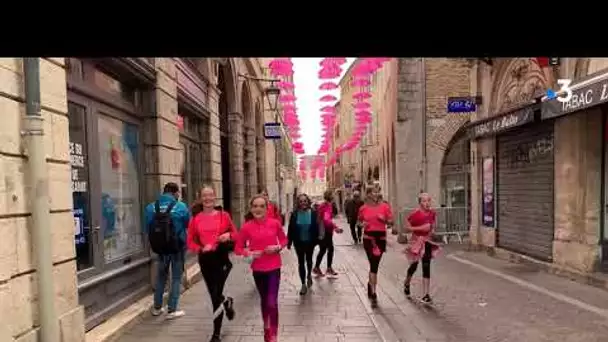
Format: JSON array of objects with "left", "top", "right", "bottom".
[{"left": 467, "top": 244, "right": 608, "bottom": 291}]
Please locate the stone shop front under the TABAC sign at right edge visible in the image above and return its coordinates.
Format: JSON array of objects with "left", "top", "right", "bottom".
[{"left": 541, "top": 70, "right": 608, "bottom": 272}]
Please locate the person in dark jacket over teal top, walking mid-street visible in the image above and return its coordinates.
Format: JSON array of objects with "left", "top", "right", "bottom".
[{"left": 287, "top": 194, "right": 319, "bottom": 296}]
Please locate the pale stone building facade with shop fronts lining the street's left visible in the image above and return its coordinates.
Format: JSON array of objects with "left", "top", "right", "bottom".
[{"left": 0, "top": 58, "right": 290, "bottom": 342}]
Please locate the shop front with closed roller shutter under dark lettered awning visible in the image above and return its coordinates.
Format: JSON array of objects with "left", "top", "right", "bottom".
[{"left": 471, "top": 104, "right": 554, "bottom": 261}]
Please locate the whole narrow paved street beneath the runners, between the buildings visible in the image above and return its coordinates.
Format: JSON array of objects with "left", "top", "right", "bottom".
[{"left": 115, "top": 221, "right": 608, "bottom": 342}]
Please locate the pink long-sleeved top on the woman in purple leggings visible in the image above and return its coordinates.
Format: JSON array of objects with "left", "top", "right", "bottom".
[{"left": 234, "top": 218, "right": 287, "bottom": 272}]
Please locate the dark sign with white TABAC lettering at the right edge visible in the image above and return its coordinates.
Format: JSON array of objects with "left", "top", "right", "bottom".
[{"left": 541, "top": 74, "right": 608, "bottom": 120}]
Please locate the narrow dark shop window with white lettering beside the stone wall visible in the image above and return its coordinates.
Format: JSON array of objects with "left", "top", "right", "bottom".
[{"left": 68, "top": 102, "right": 93, "bottom": 271}]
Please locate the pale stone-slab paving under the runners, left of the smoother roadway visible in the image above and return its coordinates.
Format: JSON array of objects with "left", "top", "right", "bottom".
[{"left": 119, "top": 218, "right": 383, "bottom": 342}]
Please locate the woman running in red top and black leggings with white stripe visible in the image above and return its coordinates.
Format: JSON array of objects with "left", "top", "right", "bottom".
[{"left": 187, "top": 185, "right": 236, "bottom": 342}]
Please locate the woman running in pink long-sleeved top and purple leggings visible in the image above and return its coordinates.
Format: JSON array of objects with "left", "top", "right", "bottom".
[{"left": 235, "top": 195, "right": 287, "bottom": 342}]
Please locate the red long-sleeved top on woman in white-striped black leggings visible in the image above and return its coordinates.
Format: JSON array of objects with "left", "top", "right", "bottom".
[{"left": 186, "top": 211, "right": 236, "bottom": 253}]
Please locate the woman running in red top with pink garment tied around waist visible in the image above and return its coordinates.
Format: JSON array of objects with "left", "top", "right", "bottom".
[{"left": 403, "top": 193, "right": 439, "bottom": 304}]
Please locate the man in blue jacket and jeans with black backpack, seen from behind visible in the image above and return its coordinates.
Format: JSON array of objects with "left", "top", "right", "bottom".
[{"left": 144, "top": 183, "right": 190, "bottom": 319}]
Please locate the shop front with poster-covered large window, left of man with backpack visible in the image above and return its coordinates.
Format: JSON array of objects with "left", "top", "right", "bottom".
[{"left": 67, "top": 58, "right": 154, "bottom": 330}]
